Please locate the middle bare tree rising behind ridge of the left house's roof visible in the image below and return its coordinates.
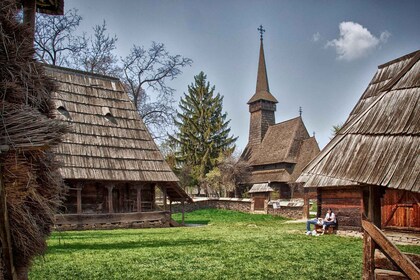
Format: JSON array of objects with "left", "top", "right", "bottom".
[{"left": 74, "top": 20, "right": 118, "bottom": 76}]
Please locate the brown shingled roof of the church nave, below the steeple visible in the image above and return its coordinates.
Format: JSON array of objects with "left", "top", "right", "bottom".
[{"left": 244, "top": 117, "right": 319, "bottom": 183}]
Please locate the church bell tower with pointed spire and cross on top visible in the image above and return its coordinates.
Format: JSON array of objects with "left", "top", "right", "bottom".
[{"left": 248, "top": 25, "right": 278, "bottom": 146}]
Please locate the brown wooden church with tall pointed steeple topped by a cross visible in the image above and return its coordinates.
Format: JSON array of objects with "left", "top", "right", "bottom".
[{"left": 241, "top": 26, "right": 319, "bottom": 199}]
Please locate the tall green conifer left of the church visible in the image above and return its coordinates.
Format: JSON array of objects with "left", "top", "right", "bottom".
[{"left": 170, "top": 72, "right": 237, "bottom": 194}]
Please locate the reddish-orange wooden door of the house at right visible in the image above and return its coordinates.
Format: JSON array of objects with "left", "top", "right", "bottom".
[{"left": 381, "top": 189, "right": 420, "bottom": 230}]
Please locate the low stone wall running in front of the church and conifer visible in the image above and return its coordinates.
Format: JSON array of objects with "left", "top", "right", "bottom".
[{"left": 172, "top": 198, "right": 303, "bottom": 219}]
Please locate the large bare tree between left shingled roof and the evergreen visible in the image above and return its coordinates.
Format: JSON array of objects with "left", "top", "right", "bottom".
[{"left": 122, "top": 42, "right": 192, "bottom": 139}]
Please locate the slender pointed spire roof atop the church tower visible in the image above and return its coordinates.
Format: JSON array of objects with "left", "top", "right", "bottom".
[{"left": 248, "top": 39, "right": 278, "bottom": 104}]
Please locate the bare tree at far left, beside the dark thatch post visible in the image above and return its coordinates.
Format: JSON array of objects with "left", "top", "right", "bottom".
[{"left": 34, "top": 9, "right": 86, "bottom": 66}]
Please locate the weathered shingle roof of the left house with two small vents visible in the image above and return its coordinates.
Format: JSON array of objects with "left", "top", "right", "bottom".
[{"left": 46, "top": 66, "right": 190, "bottom": 201}]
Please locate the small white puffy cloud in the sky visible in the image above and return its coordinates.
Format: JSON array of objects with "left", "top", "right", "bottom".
[{"left": 326, "top": 21, "right": 391, "bottom": 61}]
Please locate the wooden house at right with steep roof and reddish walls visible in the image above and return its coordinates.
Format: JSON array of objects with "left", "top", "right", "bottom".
[{"left": 299, "top": 51, "right": 420, "bottom": 231}]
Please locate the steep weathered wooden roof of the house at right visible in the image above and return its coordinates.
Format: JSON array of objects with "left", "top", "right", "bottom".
[{"left": 299, "top": 51, "right": 420, "bottom": 192}]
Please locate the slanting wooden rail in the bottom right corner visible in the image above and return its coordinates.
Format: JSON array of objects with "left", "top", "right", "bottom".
[{"left": 362, "top": 220, "right": 420, "bottom": 279}]
